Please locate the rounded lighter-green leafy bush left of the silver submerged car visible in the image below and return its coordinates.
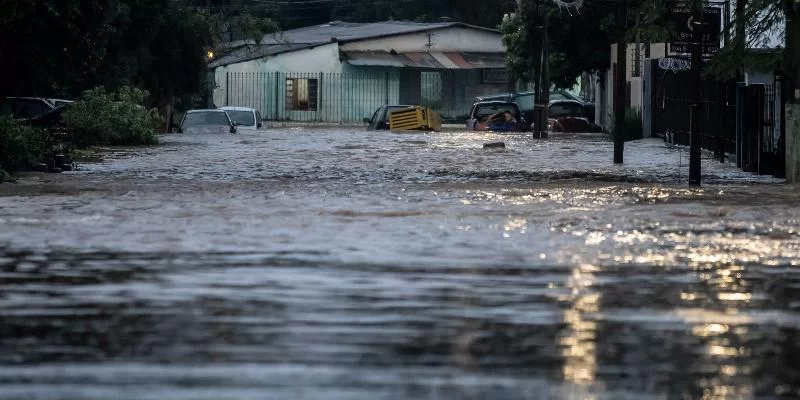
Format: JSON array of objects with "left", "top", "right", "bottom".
[{"left": 64, "top": 86, "right": 161, "bottom": 147}]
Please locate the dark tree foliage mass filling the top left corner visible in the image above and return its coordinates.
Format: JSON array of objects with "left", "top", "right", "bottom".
[{"left": 0, "top": 0, "right": 210, "bottom": 104}]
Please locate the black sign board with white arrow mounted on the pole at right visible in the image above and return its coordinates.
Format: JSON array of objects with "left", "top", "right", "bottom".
[{"left": 667, "top": 3, "right": 722, "bottom": 58}]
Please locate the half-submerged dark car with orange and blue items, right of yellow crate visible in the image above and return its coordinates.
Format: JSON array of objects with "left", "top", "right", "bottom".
[{"left": 467, "top": 101, "right": 531, "bottom": 132}]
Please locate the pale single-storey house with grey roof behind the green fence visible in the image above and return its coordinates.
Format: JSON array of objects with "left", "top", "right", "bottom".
[{"left": 208, "top": 21, "right": 509, "bottom": 122}]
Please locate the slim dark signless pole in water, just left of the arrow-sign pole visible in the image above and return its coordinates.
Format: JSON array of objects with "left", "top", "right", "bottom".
[{"left": 614, "top": 0, "right": 628, "bottom": 164}]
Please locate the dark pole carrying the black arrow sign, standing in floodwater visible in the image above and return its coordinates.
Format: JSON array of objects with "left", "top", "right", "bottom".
[{"left": 689, "top": 1, "right": 705, "bottom": 186}]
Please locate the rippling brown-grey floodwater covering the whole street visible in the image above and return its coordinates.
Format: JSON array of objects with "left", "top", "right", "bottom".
[{"left": 0, "top": 128, "right": 800, "bottom": 400}]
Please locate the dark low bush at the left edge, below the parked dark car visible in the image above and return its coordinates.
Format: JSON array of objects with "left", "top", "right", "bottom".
[{"left": 0, "top": 119, "right": 55, "bottom": 171}]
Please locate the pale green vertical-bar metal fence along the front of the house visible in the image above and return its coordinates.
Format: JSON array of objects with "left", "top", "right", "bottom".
[{"left": 222, "top": 71, "right": 503, "bottom": 123}]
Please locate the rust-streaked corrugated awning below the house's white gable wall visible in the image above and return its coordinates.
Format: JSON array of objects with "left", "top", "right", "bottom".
[{"left": 341, "top": 51, "right": 505, "bottom": 69}]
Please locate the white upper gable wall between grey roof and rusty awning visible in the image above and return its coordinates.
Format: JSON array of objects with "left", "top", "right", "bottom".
[{"left": 340, "top": 27, "right": 505, "bottom": 53}]
